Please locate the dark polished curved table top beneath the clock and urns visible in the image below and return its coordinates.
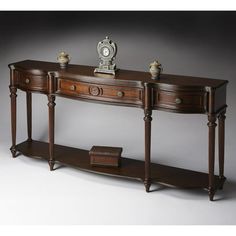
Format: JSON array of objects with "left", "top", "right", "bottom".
[{"left": 9, "top": 60, "right": 228, "bottom": 88}]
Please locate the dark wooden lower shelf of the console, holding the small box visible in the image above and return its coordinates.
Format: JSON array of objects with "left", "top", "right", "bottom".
[{"left": 16, "top": 141, "right": 224, "bottom": 189}]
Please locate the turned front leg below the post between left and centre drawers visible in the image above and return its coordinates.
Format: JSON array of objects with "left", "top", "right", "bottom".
[{"left": 48, "top": 95, "right": 56, "bottom": 171}]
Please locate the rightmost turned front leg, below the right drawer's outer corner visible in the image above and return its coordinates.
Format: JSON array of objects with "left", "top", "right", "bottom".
[{"left": 207, "top": 115, "right": 216, "bottom": 201}]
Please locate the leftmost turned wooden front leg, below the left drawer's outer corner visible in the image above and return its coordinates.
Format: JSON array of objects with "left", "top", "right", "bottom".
[{"left": 9, "top": 86, "right": 17, "bottom": 157}]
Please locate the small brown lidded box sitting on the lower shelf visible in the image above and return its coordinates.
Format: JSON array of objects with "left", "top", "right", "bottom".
[{"left": 89, "top": 146, "right": 122, "bottom": 167}]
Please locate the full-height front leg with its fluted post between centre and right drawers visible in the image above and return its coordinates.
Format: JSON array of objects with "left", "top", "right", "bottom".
[{"left": 144, "top": 84, "right": 152, "bottom": 192}]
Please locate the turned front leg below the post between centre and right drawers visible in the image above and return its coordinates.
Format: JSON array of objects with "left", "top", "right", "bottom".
[{"left": 144, "top": 110, "right": 152, "bottom": 192}]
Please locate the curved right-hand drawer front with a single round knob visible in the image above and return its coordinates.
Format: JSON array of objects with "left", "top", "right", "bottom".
[{"left": 154, "top": 90, "right": 207, "bottom": 113}]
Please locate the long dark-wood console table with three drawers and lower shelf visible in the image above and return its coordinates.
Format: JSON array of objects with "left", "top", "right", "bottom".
[{"left": 9, "top": 60, "right": 228, "bottom": 201}]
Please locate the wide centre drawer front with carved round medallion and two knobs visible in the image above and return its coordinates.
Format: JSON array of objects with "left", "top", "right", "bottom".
[{"left": 57, "top": 78, "right": 142, "bottom": 105}]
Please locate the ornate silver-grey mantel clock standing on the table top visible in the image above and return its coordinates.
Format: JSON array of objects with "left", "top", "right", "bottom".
[{"left": 94, "top": 36, "right": 117, "bottom": 75}]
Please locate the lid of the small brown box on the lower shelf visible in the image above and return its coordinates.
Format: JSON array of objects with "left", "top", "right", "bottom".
[{"left": 89, "top": 146, "right": 123, "bottom": 157}]
